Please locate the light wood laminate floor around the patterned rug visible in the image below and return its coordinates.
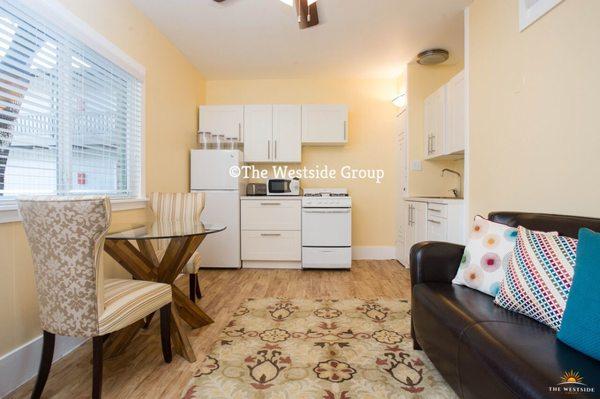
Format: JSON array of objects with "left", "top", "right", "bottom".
[{"left": 8, "top": 260, "right": 410, "bottom": 398}]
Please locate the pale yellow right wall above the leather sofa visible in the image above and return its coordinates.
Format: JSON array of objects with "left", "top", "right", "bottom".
[{"left": 468, "top": 0, "right": 600, "bottom": 217}]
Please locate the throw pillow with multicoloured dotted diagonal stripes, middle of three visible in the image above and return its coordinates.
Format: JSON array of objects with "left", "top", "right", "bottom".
[{"left": 494, "top": 226, "right": 577, "bottom": 330}]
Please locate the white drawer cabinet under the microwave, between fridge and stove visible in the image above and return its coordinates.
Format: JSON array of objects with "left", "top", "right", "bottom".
[{"left": 241, "top": 197, "right": 302, "bottom": 269}]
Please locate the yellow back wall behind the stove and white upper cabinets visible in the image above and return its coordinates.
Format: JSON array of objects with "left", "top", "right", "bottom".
[{"left": 206, "top": 79, "right": 398, "bottom": 246}]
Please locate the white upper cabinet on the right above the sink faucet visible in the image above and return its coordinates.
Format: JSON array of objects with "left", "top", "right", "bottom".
[{"left": 423, "top": 71, "right": 466, "bottom": 159}]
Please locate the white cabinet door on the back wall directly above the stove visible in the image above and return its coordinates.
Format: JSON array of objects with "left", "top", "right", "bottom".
[{"left": 302, "top": 104, "right": 348, "bottom": 144}]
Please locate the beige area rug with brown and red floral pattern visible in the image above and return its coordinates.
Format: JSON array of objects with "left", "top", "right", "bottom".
[{"left": 183, "top": 298, "right": 456, "bottom": 399}]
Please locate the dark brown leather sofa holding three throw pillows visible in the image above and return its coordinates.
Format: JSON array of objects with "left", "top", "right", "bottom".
[{"left": 410, "top": 212, "right": 600, "bottom": 399}]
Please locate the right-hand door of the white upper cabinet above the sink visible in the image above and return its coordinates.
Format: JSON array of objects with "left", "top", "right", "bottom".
[{"left": 446, "top": 71, "right": 467, "bottom": 154}]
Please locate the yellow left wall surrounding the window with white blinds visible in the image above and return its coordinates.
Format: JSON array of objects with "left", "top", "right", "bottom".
[{"left": 0, "top": 0, "right": 206, "bottom": 356}]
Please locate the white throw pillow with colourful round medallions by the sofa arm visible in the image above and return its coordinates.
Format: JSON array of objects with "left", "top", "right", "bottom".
[{"left": 452, "top": 216, "right": 517, "bottom": 296}]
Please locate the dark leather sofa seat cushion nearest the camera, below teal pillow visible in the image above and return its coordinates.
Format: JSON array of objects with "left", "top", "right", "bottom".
[{"left": 458, "top": 318, "right": 600, "bottom": 399}]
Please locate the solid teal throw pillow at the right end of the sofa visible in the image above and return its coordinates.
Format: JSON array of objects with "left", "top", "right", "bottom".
[{"left": 557, "top": 229, "right": 600, "bottom": 360}]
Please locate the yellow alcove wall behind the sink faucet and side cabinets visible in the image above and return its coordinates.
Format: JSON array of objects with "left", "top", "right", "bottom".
[{"left": 407, "top": 63, "right": 464, "bottom": 196}]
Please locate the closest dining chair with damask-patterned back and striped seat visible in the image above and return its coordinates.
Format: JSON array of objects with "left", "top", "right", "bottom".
[{"left": 18, "top": 197, "right": 172, "bottom": 399}]
